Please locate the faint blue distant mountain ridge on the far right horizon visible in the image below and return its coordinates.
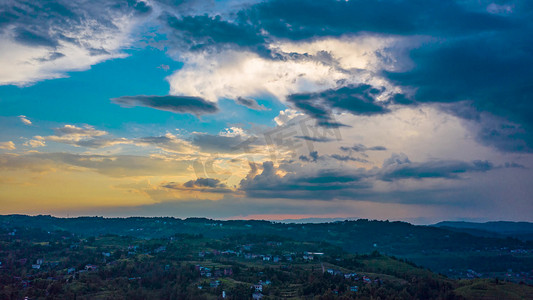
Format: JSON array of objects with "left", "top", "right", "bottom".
[{"left": 431, "top": 221, "right": 533, "bottom": 240}]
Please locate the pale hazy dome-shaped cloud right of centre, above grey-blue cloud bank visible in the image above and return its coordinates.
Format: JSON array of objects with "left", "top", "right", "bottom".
[{"left": 299, "top": 105, "right": 502, "bottom": 167}]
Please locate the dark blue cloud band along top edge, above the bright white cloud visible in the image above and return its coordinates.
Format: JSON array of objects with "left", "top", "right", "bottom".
[{"left": 249, "top": 0, "right": 512, "bottom": 39}]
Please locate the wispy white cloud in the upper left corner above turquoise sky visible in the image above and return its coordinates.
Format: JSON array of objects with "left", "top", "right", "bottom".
[{"left": 0, "top": 9, "right": 144, "bottom": 86}]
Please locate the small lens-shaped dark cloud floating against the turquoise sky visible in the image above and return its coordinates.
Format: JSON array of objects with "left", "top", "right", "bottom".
[{"left": 111, "top": 95, "right": 218, "bottom": 116}]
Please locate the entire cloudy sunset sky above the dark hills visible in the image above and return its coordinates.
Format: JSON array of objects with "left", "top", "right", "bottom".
[{"left": 0, "top": 0, "right": 533, "bottom": 224}]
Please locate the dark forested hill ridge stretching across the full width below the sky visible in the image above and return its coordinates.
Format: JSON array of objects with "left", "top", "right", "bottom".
[{"left": 0, "top": 215, "right": 533, "bottom": 283}]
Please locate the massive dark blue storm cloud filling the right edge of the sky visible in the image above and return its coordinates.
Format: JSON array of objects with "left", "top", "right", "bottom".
[{"left": 387, "top": 28, "right": 533, "bottom": 151}]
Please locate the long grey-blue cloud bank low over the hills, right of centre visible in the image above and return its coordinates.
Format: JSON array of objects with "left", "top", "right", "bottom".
[{"left": 240, "top": 154, "right": 508, "bottom": 202}]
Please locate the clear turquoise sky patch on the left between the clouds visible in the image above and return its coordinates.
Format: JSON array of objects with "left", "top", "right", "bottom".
[{"left": 0, "top": 48, "right": 284, "bottom": 134}]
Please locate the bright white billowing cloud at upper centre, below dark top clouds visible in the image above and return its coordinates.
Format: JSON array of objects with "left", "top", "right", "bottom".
[{"left": 167, "top": 36, "right": 408, "bottom": 101}]
